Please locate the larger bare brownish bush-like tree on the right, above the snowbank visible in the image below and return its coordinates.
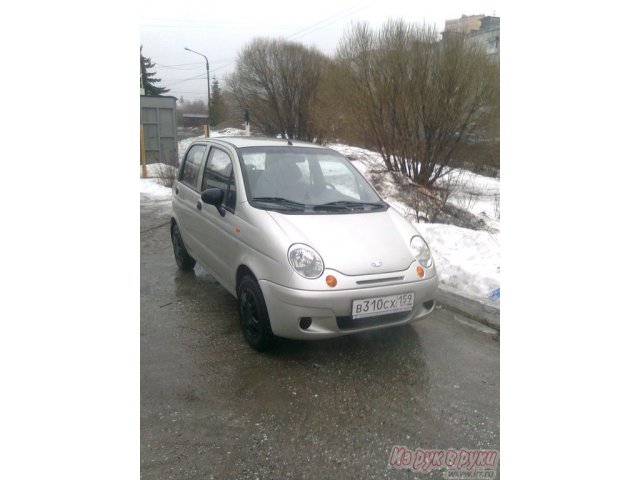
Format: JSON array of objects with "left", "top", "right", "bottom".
[{"left": 336, "top": 20, "right": 498, "bottom": 187}]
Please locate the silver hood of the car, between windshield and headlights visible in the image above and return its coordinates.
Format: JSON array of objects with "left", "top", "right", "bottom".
[{"left": 269, "top": 209, "right": 417, "bottom": 275}]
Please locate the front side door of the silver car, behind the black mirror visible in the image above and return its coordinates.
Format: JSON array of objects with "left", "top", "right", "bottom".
[{"left": 197, "top": 146, "right": 238, "bottom": 291}]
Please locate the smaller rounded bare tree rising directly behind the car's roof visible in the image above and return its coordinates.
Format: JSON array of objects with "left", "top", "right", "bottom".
[{"left": 227, "top": 39, "right": 328, "bottom": 141}]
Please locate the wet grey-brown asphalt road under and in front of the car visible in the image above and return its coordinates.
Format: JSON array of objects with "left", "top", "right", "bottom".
[{"left": 140, "top": 193, "right": 500, "bottom": 479}]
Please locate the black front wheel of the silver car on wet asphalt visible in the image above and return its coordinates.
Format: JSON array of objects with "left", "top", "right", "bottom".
[{"left": 238, "top": 275, "right": 275, "bottom": 352}]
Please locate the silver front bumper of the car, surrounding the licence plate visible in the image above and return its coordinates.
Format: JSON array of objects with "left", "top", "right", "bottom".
[{"left": 259, "top": 275, "right": 438, "bottom": 340}]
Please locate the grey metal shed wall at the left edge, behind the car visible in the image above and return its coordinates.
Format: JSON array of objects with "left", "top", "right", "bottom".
[{"left": 140, "top": 95, "right": 178, "bottom": 167}]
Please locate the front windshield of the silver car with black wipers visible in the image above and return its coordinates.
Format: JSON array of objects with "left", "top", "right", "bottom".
[{"left": 238, "top": 146, "right": 387, "bottom": 214}]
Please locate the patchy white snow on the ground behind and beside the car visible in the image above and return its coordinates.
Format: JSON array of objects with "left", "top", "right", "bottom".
[{"left": 140, "top": 135, "right": 500, "bottom": 304}]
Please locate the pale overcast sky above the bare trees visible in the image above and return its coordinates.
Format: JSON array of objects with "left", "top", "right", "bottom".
[{"left": 140, "top": 0, "right": 500, "bottom": 99}]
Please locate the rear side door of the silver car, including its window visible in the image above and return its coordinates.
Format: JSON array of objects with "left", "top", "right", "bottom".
[{"left": 173, "top": 144, "right": 207, "bottom": 260}]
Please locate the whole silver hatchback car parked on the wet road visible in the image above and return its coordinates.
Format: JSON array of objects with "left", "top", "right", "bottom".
[{"left": 171, "top": 137, "right": 438, "bottom": 350}]
